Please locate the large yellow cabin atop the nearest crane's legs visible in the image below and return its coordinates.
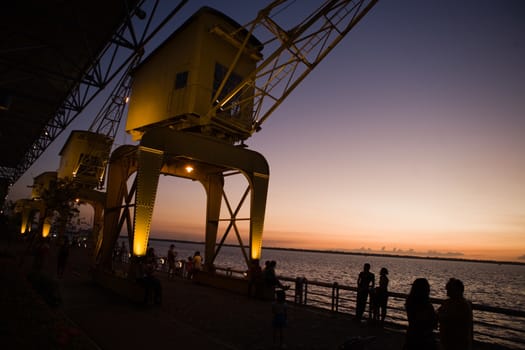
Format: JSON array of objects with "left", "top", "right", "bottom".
[{"left": 126, "top": 7, "right": 262, "bottom": 143}]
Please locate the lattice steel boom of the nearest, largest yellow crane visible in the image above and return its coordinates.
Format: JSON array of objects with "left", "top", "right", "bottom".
[{"left": 207, "top": 0, "right": 377, "bottom": 138}]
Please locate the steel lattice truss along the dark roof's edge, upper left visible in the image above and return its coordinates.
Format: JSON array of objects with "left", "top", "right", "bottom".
[{"left": 0, "top": 0, "right": 188, "bottom": 184}]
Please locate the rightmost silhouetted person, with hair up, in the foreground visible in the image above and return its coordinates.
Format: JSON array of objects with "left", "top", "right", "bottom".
[{"left": 438, "top": 278, "right": 473, "bottom": 350}]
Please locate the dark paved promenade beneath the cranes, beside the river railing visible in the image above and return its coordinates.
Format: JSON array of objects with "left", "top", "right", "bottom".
[{"left": 0, "top": 241, "right": 508, "bottom": 350}]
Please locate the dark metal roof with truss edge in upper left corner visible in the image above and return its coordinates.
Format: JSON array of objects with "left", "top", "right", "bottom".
[{"left": 0, "top": 0, "right": 187, "bottom": 202}]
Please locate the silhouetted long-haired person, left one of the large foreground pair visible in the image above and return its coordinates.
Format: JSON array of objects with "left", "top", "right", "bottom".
[{"left": 404, "top": 278, "right": 438, "bottom": 350}]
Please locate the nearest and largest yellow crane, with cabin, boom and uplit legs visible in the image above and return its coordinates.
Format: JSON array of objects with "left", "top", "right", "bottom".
[{"left": 98, "top": 0, "right": 377, "bottom": 271}]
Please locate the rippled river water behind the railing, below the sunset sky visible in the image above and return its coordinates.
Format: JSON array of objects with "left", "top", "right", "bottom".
[{"left": 127, "top": 240, "right": 525, "bottom": 348}]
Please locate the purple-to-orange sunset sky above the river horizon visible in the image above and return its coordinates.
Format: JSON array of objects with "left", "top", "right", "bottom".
[{"left": 9, "top": 0, "right": 525, "bottom": 260}]
